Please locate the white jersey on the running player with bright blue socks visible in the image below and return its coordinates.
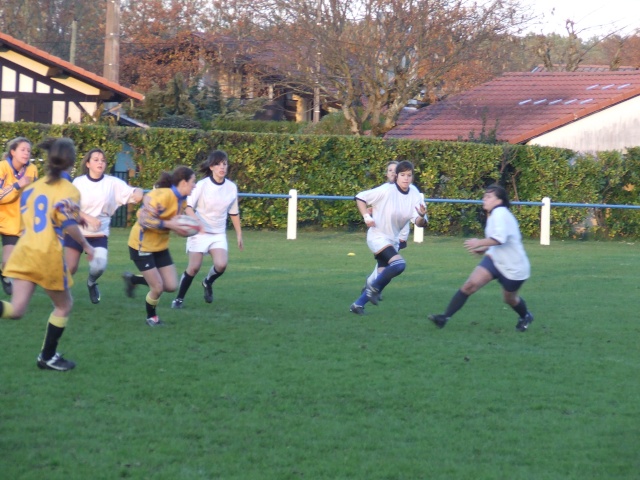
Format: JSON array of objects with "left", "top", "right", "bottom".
[{"left": 356, "top": 183, "right": 423, "bottom": 253}]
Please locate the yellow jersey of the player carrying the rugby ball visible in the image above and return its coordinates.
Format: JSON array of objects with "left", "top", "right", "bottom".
[{"left": 129, "top": 187, "right": 187, "bottom": 252}]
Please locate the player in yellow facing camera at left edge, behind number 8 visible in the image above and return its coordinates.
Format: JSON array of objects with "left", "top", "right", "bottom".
[{"left": 0, "top": 137, "right": 38, "bottom": 295}]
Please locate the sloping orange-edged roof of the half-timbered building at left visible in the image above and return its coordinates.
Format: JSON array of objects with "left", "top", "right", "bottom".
[{"left": 0, "top": 32, "right": 144, "bottom": 101}]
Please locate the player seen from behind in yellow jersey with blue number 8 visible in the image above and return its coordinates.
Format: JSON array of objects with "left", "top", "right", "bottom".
[{"left": 0, "top": 138, "right": 93, "bottom": 371}]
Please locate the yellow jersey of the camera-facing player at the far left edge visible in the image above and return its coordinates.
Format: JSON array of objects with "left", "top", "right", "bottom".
[{"left": 0, "top": 159, "right": 38, "bottom": 235}]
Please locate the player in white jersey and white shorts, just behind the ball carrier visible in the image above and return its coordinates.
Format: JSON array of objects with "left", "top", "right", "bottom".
[{"left": 171, "top": 150, "right": 244, "bottom": 308}]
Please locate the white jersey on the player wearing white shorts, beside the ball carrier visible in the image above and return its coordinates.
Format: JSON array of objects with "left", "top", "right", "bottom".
[{"left": 187, "top": 177, "right": 240, "bottom": 233}]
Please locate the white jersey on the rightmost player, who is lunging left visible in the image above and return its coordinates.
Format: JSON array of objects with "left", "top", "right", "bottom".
[{"left": 484, "top": 206, "right": 531, "bottom": 280}]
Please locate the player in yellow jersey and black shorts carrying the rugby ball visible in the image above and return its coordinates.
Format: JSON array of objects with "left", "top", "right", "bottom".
[{"left": 123, "top": 166, "right": 196, "bottom": 327}]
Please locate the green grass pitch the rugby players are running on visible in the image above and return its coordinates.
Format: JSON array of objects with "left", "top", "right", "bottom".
[{"left": 0, "top": 230, "right": 640, "bottom": 480}]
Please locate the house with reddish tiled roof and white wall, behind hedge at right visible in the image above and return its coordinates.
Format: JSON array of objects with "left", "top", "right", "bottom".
[{"left": 385, "top": 70, "right": 640, "bottom": 152}]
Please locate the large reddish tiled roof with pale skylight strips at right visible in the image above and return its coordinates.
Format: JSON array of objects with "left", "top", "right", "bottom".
[{"left": 386, "top": 70, "right": 640, "bottom": 144}]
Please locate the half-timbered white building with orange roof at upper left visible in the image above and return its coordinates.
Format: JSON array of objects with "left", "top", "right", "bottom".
[{"left": 0, "top": 32, "right": 144, "bottom": 124}]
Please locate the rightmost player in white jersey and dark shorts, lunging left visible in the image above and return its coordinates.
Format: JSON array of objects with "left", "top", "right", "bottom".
[{"left": 429, "top": 185, "right": 533, "bottom": 332}]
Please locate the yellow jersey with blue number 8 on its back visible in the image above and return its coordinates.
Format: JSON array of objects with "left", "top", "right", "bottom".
[{"left": 3, "top": 177, "right": 80, "bottom": 290}]
